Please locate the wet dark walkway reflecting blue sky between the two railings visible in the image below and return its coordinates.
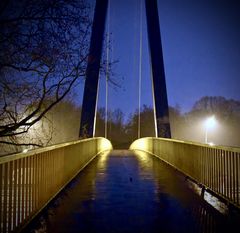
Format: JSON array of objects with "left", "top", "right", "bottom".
[{"left": 24, "top": 150, "right": 238, "bottom": 233}]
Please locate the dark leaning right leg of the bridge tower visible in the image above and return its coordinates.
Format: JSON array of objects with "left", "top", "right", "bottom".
[{"left": 145, "top": 0, "right": 171, "bottom": 138}]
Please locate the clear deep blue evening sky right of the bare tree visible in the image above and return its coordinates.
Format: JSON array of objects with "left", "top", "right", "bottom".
[{"left": 79, "top": 0, "right": 240, "bottom": 116}]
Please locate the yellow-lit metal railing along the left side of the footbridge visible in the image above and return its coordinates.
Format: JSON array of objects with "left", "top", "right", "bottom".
[{"left": 0, "top": 138, "right": 112, "bottom": 233}]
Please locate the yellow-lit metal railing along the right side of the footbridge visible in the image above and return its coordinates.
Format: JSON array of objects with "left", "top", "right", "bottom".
[{"left": 130, "top": 138, "right": 240, "bottom": 207}]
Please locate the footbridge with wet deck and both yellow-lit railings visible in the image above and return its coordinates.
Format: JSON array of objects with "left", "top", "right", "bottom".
[{"left": 0, "top": 138, "right": 240, "bottom": 233}]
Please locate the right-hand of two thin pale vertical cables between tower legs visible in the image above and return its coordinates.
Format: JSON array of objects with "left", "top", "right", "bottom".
[{"left": 138, "top": 1, "right": 143, "bottom": 138}]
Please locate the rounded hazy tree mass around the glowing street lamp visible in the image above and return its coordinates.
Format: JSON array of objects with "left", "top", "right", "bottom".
[{"left": 180, "top": 96, "right": 240, "bottom": 147}]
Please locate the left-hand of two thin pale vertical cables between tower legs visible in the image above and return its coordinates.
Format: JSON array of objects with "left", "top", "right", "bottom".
[{"left": 104, "top": 0, "right": 111, "bottom": 138}]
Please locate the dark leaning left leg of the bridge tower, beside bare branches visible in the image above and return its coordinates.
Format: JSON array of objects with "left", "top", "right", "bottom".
[{"left": 79, "top": 0, "right": 108, "bottom": 138}]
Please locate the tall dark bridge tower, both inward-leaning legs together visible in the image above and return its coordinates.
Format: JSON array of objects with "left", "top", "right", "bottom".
[{"left": 79, "top": 0, "right": 171, "bottom": 138}]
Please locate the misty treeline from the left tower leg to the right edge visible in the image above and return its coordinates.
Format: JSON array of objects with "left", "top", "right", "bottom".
[{"left": 96, "top": 96, "right": 240, "bottom": 148}]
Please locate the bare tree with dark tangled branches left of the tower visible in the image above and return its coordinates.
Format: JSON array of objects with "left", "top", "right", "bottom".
[{"left": 0, "top": 0, "right": 91, "bottom": 146}]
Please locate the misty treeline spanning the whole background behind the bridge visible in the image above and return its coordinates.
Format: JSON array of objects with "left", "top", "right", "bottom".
[{"left": 1, "top": 96, "right": 240, "bottom": 154}]
